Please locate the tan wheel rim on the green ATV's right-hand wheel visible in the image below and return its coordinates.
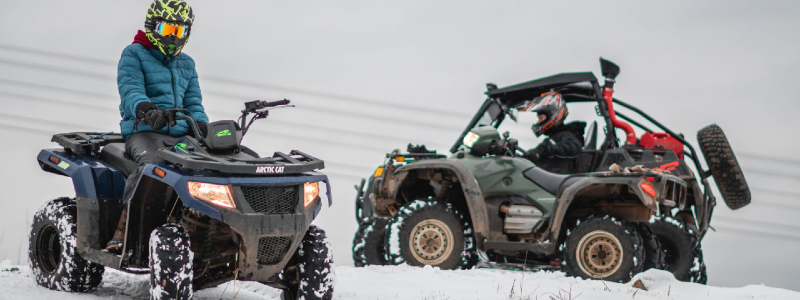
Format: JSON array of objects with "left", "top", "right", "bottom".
[{"left": 575, "top": 230, "right": 624, "bottom": 278}]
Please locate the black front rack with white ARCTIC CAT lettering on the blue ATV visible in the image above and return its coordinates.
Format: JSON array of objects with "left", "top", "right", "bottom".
[{"left": 157, "top": 149, "right": 325, "bottom": 175}]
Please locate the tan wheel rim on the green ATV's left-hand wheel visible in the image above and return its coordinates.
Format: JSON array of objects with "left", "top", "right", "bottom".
[{"left": 409, "top": 219, "right": 453, "bottom": 265}]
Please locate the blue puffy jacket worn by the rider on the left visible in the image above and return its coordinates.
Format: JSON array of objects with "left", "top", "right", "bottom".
[{"left": 117, "top": 43, "right": 208, "bottom": 140}]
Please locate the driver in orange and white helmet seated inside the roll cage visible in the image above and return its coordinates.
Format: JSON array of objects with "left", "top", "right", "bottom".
[{"left": 523, "top": 91, "right": 586, "bottom": 163}]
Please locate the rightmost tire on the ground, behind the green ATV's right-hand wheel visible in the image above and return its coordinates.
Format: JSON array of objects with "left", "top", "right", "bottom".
[{"left": 650, "top": 216, "right": 708, "bottom": 284}]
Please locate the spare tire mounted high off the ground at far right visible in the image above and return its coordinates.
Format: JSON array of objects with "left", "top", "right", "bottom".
[{"left": 697, "top": 124, "right": 750, "bottom": 209}]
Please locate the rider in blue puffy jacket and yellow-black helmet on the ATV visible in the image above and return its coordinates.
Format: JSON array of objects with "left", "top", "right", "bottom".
[{"left": 106, "top": 0, "right": 208, "bottom": 253}]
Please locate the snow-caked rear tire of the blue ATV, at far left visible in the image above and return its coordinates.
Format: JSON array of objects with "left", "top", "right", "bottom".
[{"left": 28, "top": 198, "right": 105, "bottom": 293}]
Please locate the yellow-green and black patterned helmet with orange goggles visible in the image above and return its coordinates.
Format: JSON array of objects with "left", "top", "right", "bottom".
[{"left": 144, "top": 0, "right": 194, "bottom": 57}]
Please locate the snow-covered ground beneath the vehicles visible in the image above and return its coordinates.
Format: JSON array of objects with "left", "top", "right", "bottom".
[{"left": 0, "top": 261, "right": 800, "bottom": 300}]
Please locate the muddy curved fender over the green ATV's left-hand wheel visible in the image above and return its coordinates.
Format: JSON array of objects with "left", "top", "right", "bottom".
[{"left": 389, "top": 159, "right": 489, "bottom": 249}]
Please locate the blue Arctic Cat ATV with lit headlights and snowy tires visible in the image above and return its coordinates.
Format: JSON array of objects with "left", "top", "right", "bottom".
[{"left": 28, "top": 100, "right": 334, "bottom": 299}]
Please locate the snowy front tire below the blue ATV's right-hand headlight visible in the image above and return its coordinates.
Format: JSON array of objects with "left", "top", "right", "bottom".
[{"left": 279, "top": 225, "right": 336, "bottom": 300}]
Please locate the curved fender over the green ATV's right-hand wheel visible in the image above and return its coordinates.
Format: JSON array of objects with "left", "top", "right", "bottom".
[{"left": 550, "top": 176, "right": 659, "bottom": 241}]
